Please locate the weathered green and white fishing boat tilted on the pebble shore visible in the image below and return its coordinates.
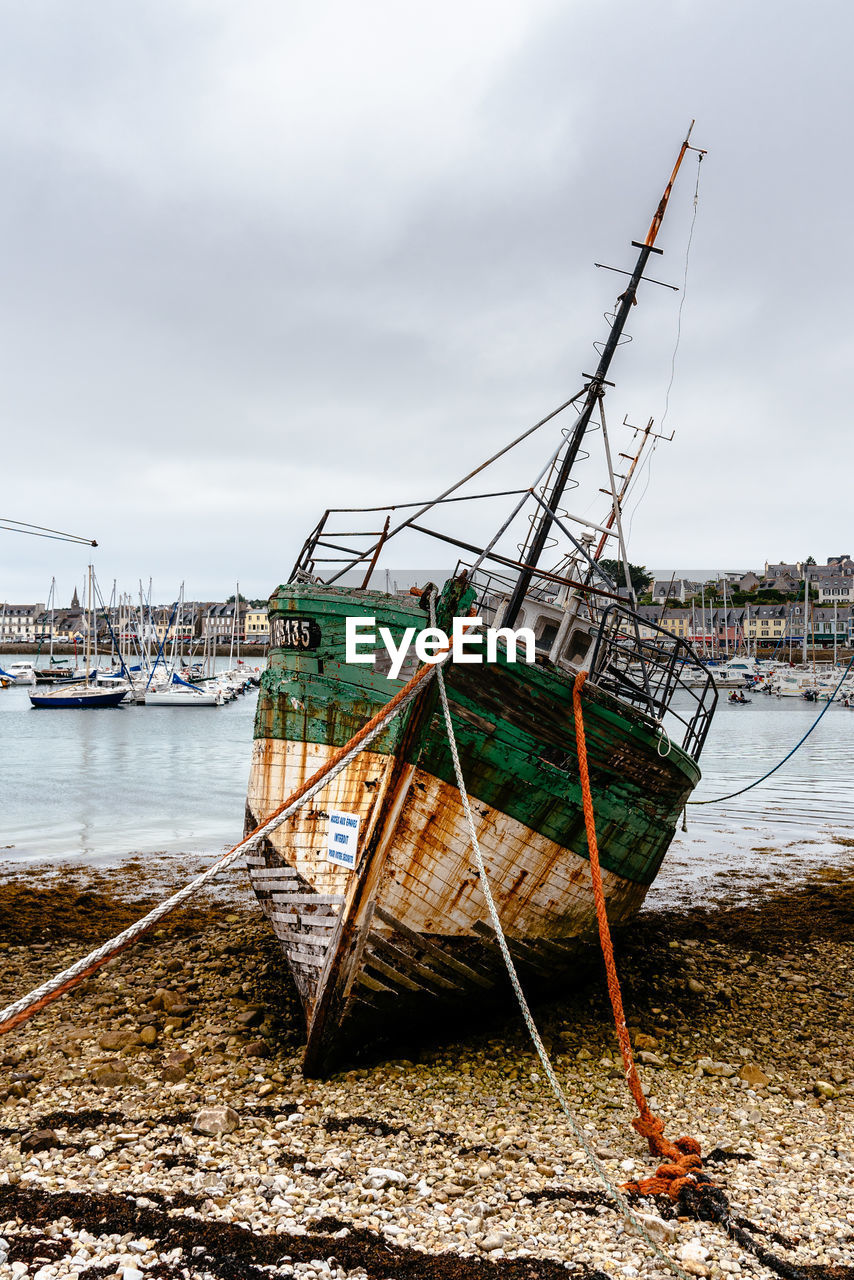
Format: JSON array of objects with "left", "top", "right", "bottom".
[{"left": 246, "top": 131, "right": 717, "bottom": 1075}]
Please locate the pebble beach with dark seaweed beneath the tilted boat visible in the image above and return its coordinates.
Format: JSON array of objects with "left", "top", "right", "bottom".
[{"left": 0, "top": 841, "right": 854, "bottom": 1280}]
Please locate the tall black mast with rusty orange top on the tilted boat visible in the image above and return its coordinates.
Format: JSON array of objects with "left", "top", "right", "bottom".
[{"left": 502, "top": 120, "right": 694, "bottom": 627}]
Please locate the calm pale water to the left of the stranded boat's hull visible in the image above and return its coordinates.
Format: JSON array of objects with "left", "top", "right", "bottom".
[{"left": 0, "top": 659, "right": 257, "bottom": 860}]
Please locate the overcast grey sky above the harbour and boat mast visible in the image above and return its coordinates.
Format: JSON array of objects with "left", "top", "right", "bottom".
[{"left": 0, "top": 0, "right": 854, "bottom": 603}]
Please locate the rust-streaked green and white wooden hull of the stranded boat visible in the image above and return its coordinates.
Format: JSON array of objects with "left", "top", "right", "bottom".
[{"left": 246, "top": 586, "right": 699, "bottom": 1074}]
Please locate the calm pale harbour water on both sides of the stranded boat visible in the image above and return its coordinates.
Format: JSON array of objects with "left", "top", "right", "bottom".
[{"left": 0, "top": 659, "right": 854, "bottom": 902}]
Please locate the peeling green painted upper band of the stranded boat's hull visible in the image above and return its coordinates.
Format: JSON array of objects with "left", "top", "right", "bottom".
[{"left": 255, "top": 586, "right": 700, "bottom": 884}]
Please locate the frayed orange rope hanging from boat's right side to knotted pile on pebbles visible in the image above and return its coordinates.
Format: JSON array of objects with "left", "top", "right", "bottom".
[{"left": 572, "top": 671, "right": 703, "bottom": 1199}]
